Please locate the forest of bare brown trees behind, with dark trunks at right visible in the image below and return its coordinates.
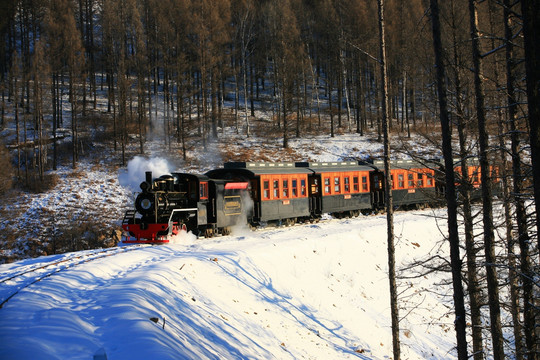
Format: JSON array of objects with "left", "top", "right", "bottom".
[{"left": 0, "top": 0, "right": 540, "bottom": 360}]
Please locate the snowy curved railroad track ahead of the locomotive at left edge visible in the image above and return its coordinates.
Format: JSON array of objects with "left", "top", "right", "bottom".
[{"left": 0, "top": 245, "right": 141, "bottom": 309}]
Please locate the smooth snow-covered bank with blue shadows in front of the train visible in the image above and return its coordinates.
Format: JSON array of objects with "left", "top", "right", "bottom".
[{"left": 0, "top": 210, "right": 455, "bottom": 360}]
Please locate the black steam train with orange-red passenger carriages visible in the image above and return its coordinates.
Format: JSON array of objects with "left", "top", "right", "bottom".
[{"left": 122, "top": 159, "right": 500, "bottom": 244}]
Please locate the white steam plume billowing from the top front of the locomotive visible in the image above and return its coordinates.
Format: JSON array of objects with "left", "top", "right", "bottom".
[{"left": 118, "top": 156, "right": 171, "bottom": 192}]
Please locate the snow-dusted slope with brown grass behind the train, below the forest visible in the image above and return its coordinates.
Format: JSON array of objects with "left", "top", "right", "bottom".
[{"left": 0, "top": 113, "right": 433, "bottom": 263}]
